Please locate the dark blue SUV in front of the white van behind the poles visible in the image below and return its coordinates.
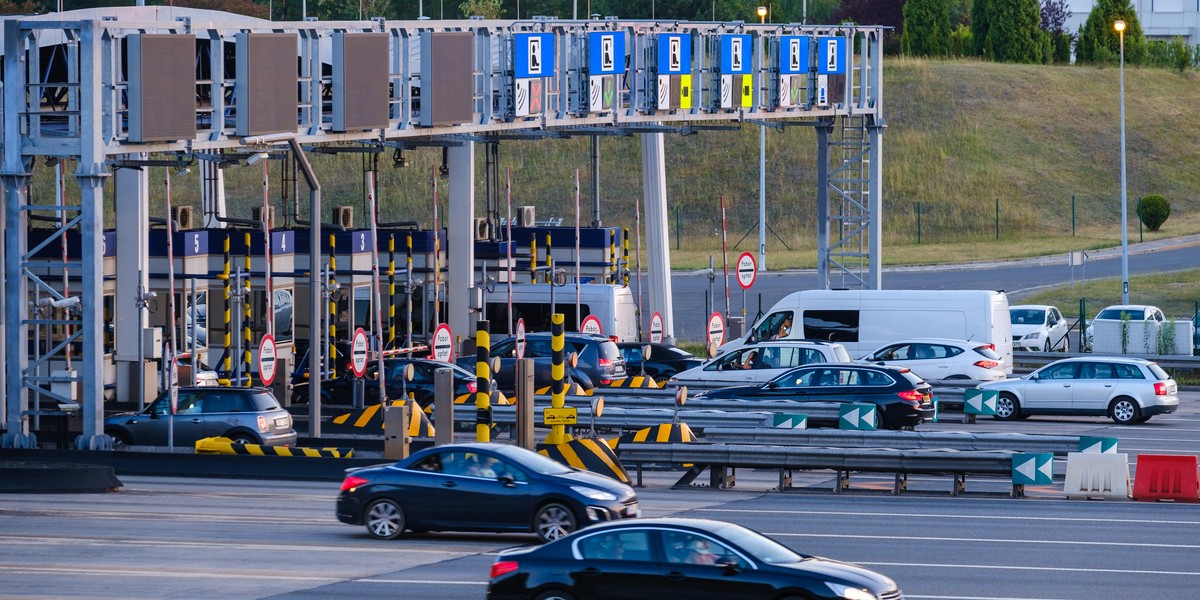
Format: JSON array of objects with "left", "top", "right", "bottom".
[{"left": 458, "top": 334, "right": 625, "bottom": 394}]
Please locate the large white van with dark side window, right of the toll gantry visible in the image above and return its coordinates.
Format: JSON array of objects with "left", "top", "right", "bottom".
[{"left": 721, "top": 289, "right": 1013, "bottom": 373}]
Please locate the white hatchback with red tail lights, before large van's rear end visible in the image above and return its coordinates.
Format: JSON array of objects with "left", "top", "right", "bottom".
[{"left": 858, "top": 337, "right": 1006, "bottom": 382}]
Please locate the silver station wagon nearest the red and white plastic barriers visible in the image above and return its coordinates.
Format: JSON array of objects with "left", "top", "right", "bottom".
[{"left": 978, "top": 356, "right": 1180, "bottom": 425}]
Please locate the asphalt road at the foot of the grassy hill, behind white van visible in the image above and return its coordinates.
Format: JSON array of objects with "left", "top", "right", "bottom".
[{"left": 652, "top": 236, "right": 1200, "bottom": 342}]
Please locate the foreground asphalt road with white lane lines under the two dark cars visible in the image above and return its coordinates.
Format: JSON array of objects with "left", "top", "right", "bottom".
[{"left": 0, "top": 392, "right": 1200, "bottom": 600}]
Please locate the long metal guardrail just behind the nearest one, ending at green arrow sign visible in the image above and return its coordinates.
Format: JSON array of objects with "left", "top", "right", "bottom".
[{"left": 704, "top": 427, "right": 1080, "bottom": 456}]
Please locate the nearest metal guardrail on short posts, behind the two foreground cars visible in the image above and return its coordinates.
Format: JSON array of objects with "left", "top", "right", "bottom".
[{"left": 617, "top": 443, "right": 1025, "bottom": 497}]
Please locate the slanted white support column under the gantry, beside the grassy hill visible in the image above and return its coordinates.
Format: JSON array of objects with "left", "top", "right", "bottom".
[{"left": 642, "top": 133, "right": 674, "bottom": 343}]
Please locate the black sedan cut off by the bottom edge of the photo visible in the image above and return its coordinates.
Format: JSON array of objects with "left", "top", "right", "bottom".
[{"left": 487, "top": 518, "right": 904, "bottom": 600}]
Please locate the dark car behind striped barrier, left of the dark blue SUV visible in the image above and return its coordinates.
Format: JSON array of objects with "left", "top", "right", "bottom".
[{"left": 292, "top": 359, "right": 476, "bottom": 408}]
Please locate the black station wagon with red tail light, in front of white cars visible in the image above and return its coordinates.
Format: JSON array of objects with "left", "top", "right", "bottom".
[{"left": 695, "top": 362, "right": 934, "bottom": 430}]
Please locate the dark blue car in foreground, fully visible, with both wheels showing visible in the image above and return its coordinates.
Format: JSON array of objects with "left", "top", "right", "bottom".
[{"left": 337, "top": 443, "right": 640, "bottom": 541}]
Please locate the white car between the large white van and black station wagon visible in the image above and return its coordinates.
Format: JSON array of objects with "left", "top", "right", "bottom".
[{"left": 670, "top": 340, "right": 851, "bottom": 388}]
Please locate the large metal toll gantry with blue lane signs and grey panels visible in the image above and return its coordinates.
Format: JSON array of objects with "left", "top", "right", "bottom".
[{"left": 0, "top": 6, "right": 884, "bottom": 449}]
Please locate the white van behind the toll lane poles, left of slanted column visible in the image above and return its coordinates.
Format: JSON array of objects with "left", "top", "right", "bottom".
[{"left": 486, "top": 283, "right": 637, "bottom": 342}]
